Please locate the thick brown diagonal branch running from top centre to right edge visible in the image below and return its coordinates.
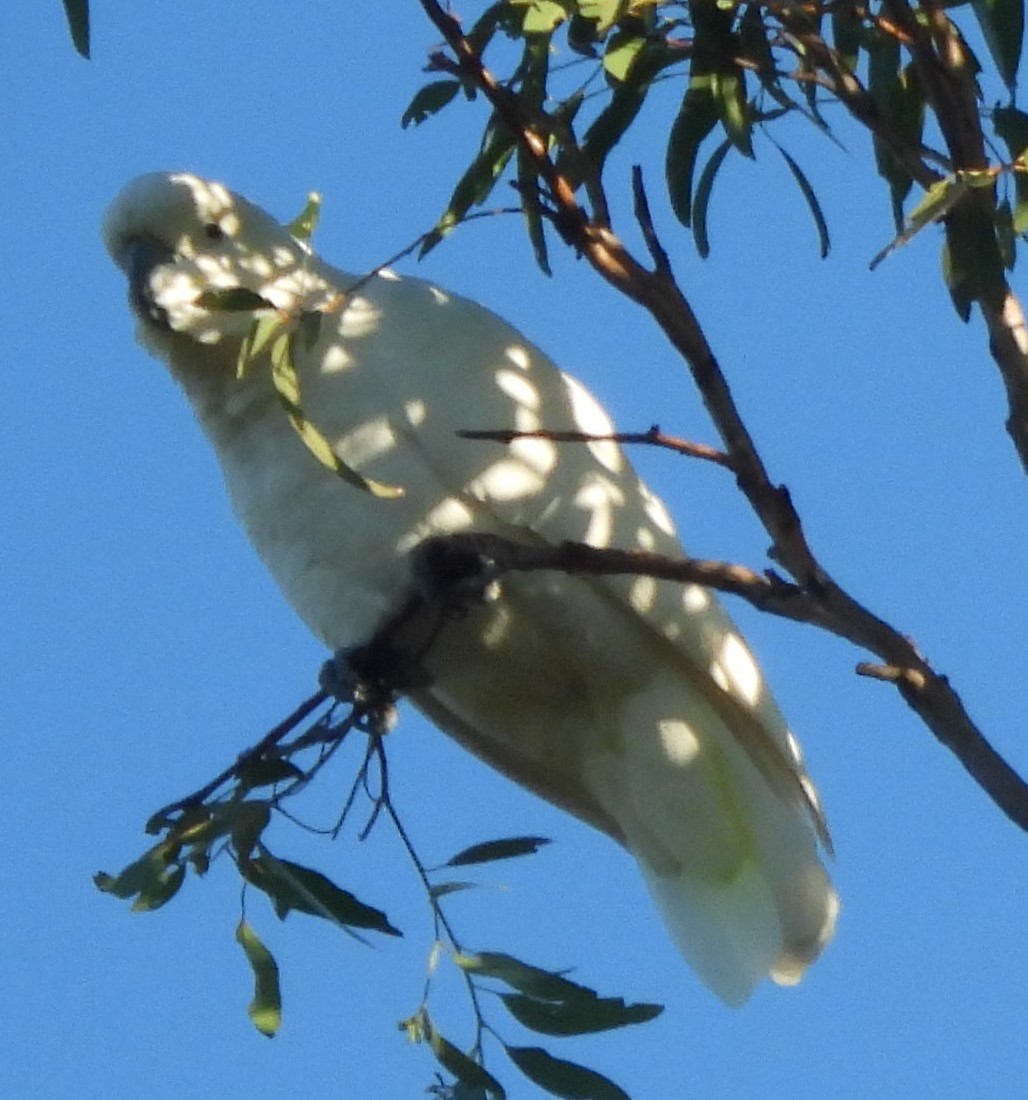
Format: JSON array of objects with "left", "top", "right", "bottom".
[{"left": 420, "top": 0, "right": 1028, "bottom": 831}]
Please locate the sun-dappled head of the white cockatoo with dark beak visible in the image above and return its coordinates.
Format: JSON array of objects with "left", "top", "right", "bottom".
[{"left": 103, "top": 173, "right": 325, "bottom": 354}]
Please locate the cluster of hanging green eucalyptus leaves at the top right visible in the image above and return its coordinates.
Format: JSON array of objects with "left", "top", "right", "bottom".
[{"left": 402, "top": 0, "right": 1028, "bottom": 319}]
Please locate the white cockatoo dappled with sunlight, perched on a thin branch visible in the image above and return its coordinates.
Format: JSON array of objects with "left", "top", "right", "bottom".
[{"left": 103, "top": 174, "right": 839, "bottom": 1004}]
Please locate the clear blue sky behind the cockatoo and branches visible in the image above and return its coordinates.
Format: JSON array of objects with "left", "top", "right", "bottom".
[{"left": 6, "top": 0, "right": 1028, "bottom": 1100}]
